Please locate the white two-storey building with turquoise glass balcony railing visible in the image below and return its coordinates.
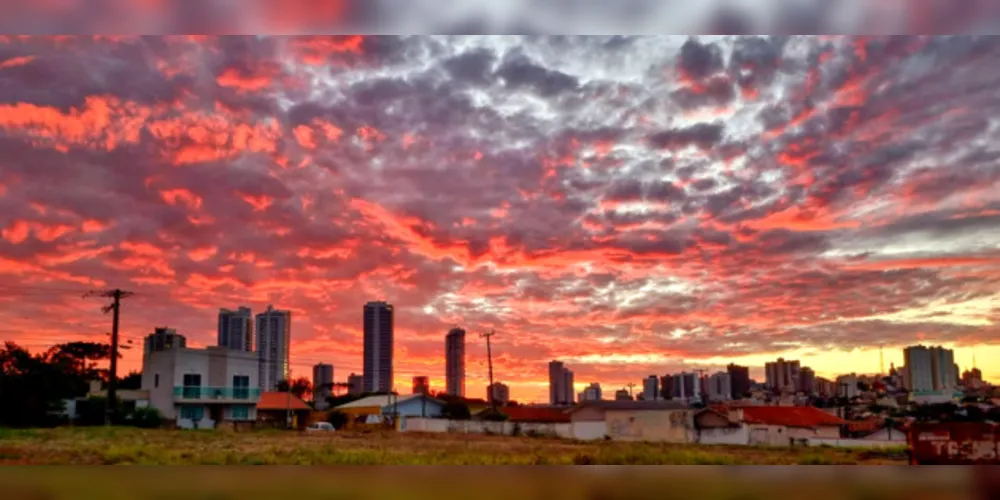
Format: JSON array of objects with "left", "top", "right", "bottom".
[{"left": 142, "top": 346, "right": 260, "bottom": 428}]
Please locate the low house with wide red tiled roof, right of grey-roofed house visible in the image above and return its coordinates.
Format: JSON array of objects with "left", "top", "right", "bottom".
[{"left": 694, "top": 406, "right": 847, "bottom": 446}]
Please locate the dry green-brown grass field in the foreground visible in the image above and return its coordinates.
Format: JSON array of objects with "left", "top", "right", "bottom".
[{"left": 0, "top": 427, "right": 906, "bottom": 465}]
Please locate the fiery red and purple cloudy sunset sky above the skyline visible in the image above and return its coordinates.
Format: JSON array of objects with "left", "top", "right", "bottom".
[{"left": 0, "top": 36, "right": 1000, "bottom": 401}]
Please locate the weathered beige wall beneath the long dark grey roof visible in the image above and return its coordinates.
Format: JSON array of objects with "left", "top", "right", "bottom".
[{"left": 605, "top": 410, "right": 695, "bottom": 443}]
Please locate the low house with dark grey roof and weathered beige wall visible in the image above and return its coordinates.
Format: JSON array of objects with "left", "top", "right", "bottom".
[{"left": 567, "top": 400, "right": 693, "bottom": 443}]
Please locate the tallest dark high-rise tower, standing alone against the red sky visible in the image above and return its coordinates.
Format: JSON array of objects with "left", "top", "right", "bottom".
[{"left": 364, "top": 302, "right": 393, "bottom": 394}]
